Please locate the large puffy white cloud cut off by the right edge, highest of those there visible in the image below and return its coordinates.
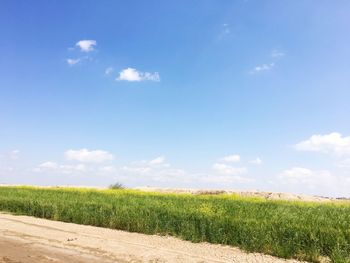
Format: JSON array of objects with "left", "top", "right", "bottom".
[{"left": 294, "top": 132, "right": 350, "bottom": 155}]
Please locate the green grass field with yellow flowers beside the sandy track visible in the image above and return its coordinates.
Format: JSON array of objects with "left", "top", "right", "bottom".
[{"left": 0, "top": 187, "right": 350, "bottom": 262}]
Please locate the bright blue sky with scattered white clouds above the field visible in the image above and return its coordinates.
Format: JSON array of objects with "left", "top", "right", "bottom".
[{"left": 0, "top": 0, "right": 350, "bottom": 197}]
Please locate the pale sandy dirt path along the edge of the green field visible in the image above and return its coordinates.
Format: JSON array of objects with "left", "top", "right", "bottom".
[{"left": 0, "top": 213, "right": 304, "bottom": 263}]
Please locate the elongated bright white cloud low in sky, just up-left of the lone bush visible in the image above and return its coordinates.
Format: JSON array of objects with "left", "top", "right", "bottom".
[{"left": 64, "top": 149, "right": 114, "bottom": 163}]
